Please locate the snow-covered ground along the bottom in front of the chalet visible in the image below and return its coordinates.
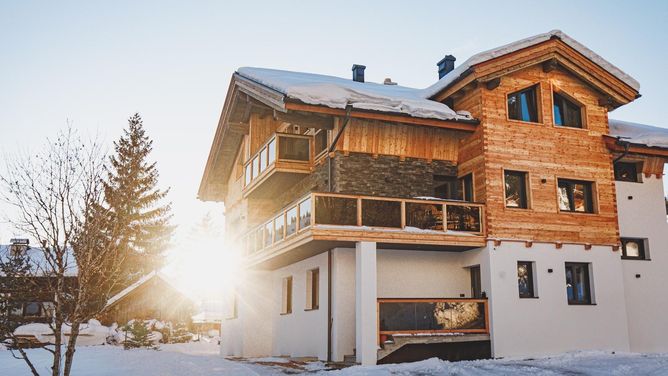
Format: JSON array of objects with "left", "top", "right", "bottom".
[{"left": 0, "top": 342, "right": 668, "bottom": 376}]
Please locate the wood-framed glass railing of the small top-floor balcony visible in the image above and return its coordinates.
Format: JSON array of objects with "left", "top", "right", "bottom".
[{"left": 244, "top": 133, "right": 313, "bottom": 189}]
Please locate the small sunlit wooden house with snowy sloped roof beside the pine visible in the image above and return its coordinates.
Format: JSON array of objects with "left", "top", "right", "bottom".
[{"left": 99, "top": 271, "right": 194, "bottom": 325}]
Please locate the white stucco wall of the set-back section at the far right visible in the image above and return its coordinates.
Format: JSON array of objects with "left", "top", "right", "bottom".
[{"left": 616, "top": 176, "right": 668, "bottom": 352}]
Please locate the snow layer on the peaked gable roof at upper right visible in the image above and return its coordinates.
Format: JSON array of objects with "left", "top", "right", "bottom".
[{"left": 423, "top": 30, "right": 640, "bottom": 98}]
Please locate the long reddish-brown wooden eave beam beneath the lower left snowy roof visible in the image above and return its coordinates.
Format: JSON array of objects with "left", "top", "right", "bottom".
[{"left": 285, "top": 102, "right": 478, "bottom": 132}]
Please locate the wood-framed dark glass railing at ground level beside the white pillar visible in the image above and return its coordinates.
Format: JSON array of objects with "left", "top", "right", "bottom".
[{"left": 378, "top": 298, "right": 489, "bottom": 343}]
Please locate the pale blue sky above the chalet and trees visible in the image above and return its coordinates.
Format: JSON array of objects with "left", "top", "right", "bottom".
[{"left": 0, "top": 0, "right": 668, "bottom": 242}]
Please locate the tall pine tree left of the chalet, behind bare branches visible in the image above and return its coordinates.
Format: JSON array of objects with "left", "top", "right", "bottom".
[{"left": 104, "top": 114, "right": 174, "bottom": 284}]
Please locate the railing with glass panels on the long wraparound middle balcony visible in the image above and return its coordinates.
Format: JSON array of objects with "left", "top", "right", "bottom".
[{"left": 242, "top": 193, "right": 484, "bottom": 254}]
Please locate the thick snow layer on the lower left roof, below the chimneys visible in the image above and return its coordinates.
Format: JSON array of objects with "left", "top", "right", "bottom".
[{"left": 237, "top": 67, "right": 472, "bottom": 120}]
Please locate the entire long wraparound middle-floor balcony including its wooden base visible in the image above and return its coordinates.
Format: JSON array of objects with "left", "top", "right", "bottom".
[{"left": 241, "top": 193, "right": 485, "bottom": 268}]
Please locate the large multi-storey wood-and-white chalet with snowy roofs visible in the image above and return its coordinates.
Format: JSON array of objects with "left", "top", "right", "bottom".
[{"left": 199, "top": 31, "right": 668, "bottom": 364}]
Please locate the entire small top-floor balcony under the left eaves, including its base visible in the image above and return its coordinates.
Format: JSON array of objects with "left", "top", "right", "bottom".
[{"left": 243, "top": 133, "right": 313, "bottom": 197}]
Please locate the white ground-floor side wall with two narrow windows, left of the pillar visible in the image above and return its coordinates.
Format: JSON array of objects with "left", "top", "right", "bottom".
[{"left": 272, "top": 252, "right": 328, "bottom": 360}]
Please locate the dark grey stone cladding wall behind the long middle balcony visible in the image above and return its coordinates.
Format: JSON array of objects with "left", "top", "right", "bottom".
[{"left": 332, "top": 153, "right": 457, "bottom": 198}]
